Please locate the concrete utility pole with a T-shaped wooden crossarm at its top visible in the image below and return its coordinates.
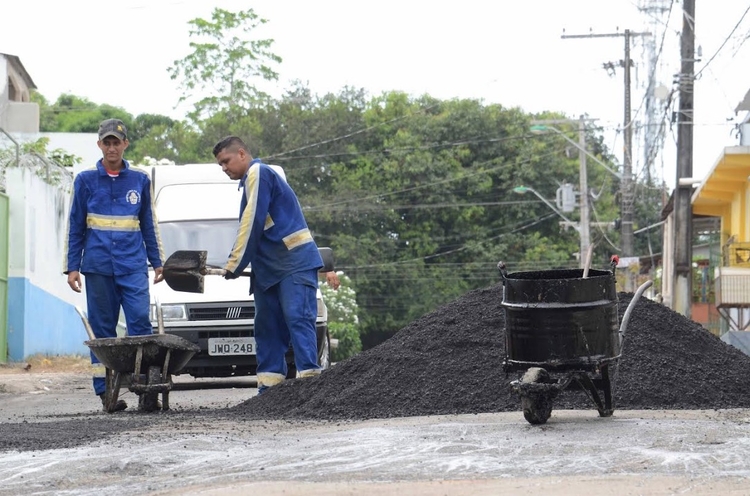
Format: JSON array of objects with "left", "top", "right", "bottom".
[{"left": 562, "top": 29, "right": 651, "bottom": 257}]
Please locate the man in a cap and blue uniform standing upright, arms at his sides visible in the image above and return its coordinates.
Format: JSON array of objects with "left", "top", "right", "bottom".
[{"left": 63, "top": 119, "right": 164, "bottom": 411}]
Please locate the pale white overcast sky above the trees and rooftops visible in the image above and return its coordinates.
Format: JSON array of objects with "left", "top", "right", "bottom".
[{"left": 0, "top": 0, "right": 750, "bottom": 190}]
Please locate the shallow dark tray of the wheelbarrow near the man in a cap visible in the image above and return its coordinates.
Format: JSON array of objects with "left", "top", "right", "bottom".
[{"left": 84, "top": 334, "right": 200, "bottom": 374}]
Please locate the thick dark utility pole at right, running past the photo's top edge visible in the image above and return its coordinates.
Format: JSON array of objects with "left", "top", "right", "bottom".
[{"left": 672, "top": 0, "right": 695, "bottom": 318}]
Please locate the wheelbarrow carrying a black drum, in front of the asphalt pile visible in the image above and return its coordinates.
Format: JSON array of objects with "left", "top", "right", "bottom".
[{"left": 498, "top": 257, "right": 653, "bottom": 424}]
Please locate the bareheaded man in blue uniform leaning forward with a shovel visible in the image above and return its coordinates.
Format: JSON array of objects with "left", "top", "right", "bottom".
[{"left": 213, "top": 136, "right": 323, "bottom": 394}]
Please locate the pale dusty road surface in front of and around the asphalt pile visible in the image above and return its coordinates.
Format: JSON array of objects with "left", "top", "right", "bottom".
[{"left": 0, "top": 362, "right": 750, "bottom": 496}]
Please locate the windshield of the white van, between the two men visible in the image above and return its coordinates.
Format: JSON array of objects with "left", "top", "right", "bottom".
[{"left": 159, "top": 219, "right": 238, "bottom": 267}]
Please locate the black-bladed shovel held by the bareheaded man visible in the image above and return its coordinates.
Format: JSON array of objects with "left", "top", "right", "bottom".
[{"left": 162, "top": 247, "right": 333, "bottom": 293}]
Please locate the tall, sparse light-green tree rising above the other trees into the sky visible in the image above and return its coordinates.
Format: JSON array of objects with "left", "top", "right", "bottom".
[{"left": 168, "top": 8, "right": 281, "bottom": 122}]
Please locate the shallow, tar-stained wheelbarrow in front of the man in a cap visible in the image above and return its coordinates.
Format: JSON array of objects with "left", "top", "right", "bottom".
[{"left": 76, "top": 300, "right": 200, "bottom": 413}]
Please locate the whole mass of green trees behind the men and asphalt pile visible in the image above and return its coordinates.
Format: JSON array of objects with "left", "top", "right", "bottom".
[{"left": 33, "top": 9, "right": 661, "bottom": 352}]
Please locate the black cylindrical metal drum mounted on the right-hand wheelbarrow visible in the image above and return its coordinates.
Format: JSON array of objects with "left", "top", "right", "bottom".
[{"left": 501, "top": 269, "right": 620, "bottom": 370}]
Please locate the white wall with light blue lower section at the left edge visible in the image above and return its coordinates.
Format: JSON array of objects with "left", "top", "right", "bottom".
[{"left": 6, "top": 167, "right": 88, "bottom": 361}]
